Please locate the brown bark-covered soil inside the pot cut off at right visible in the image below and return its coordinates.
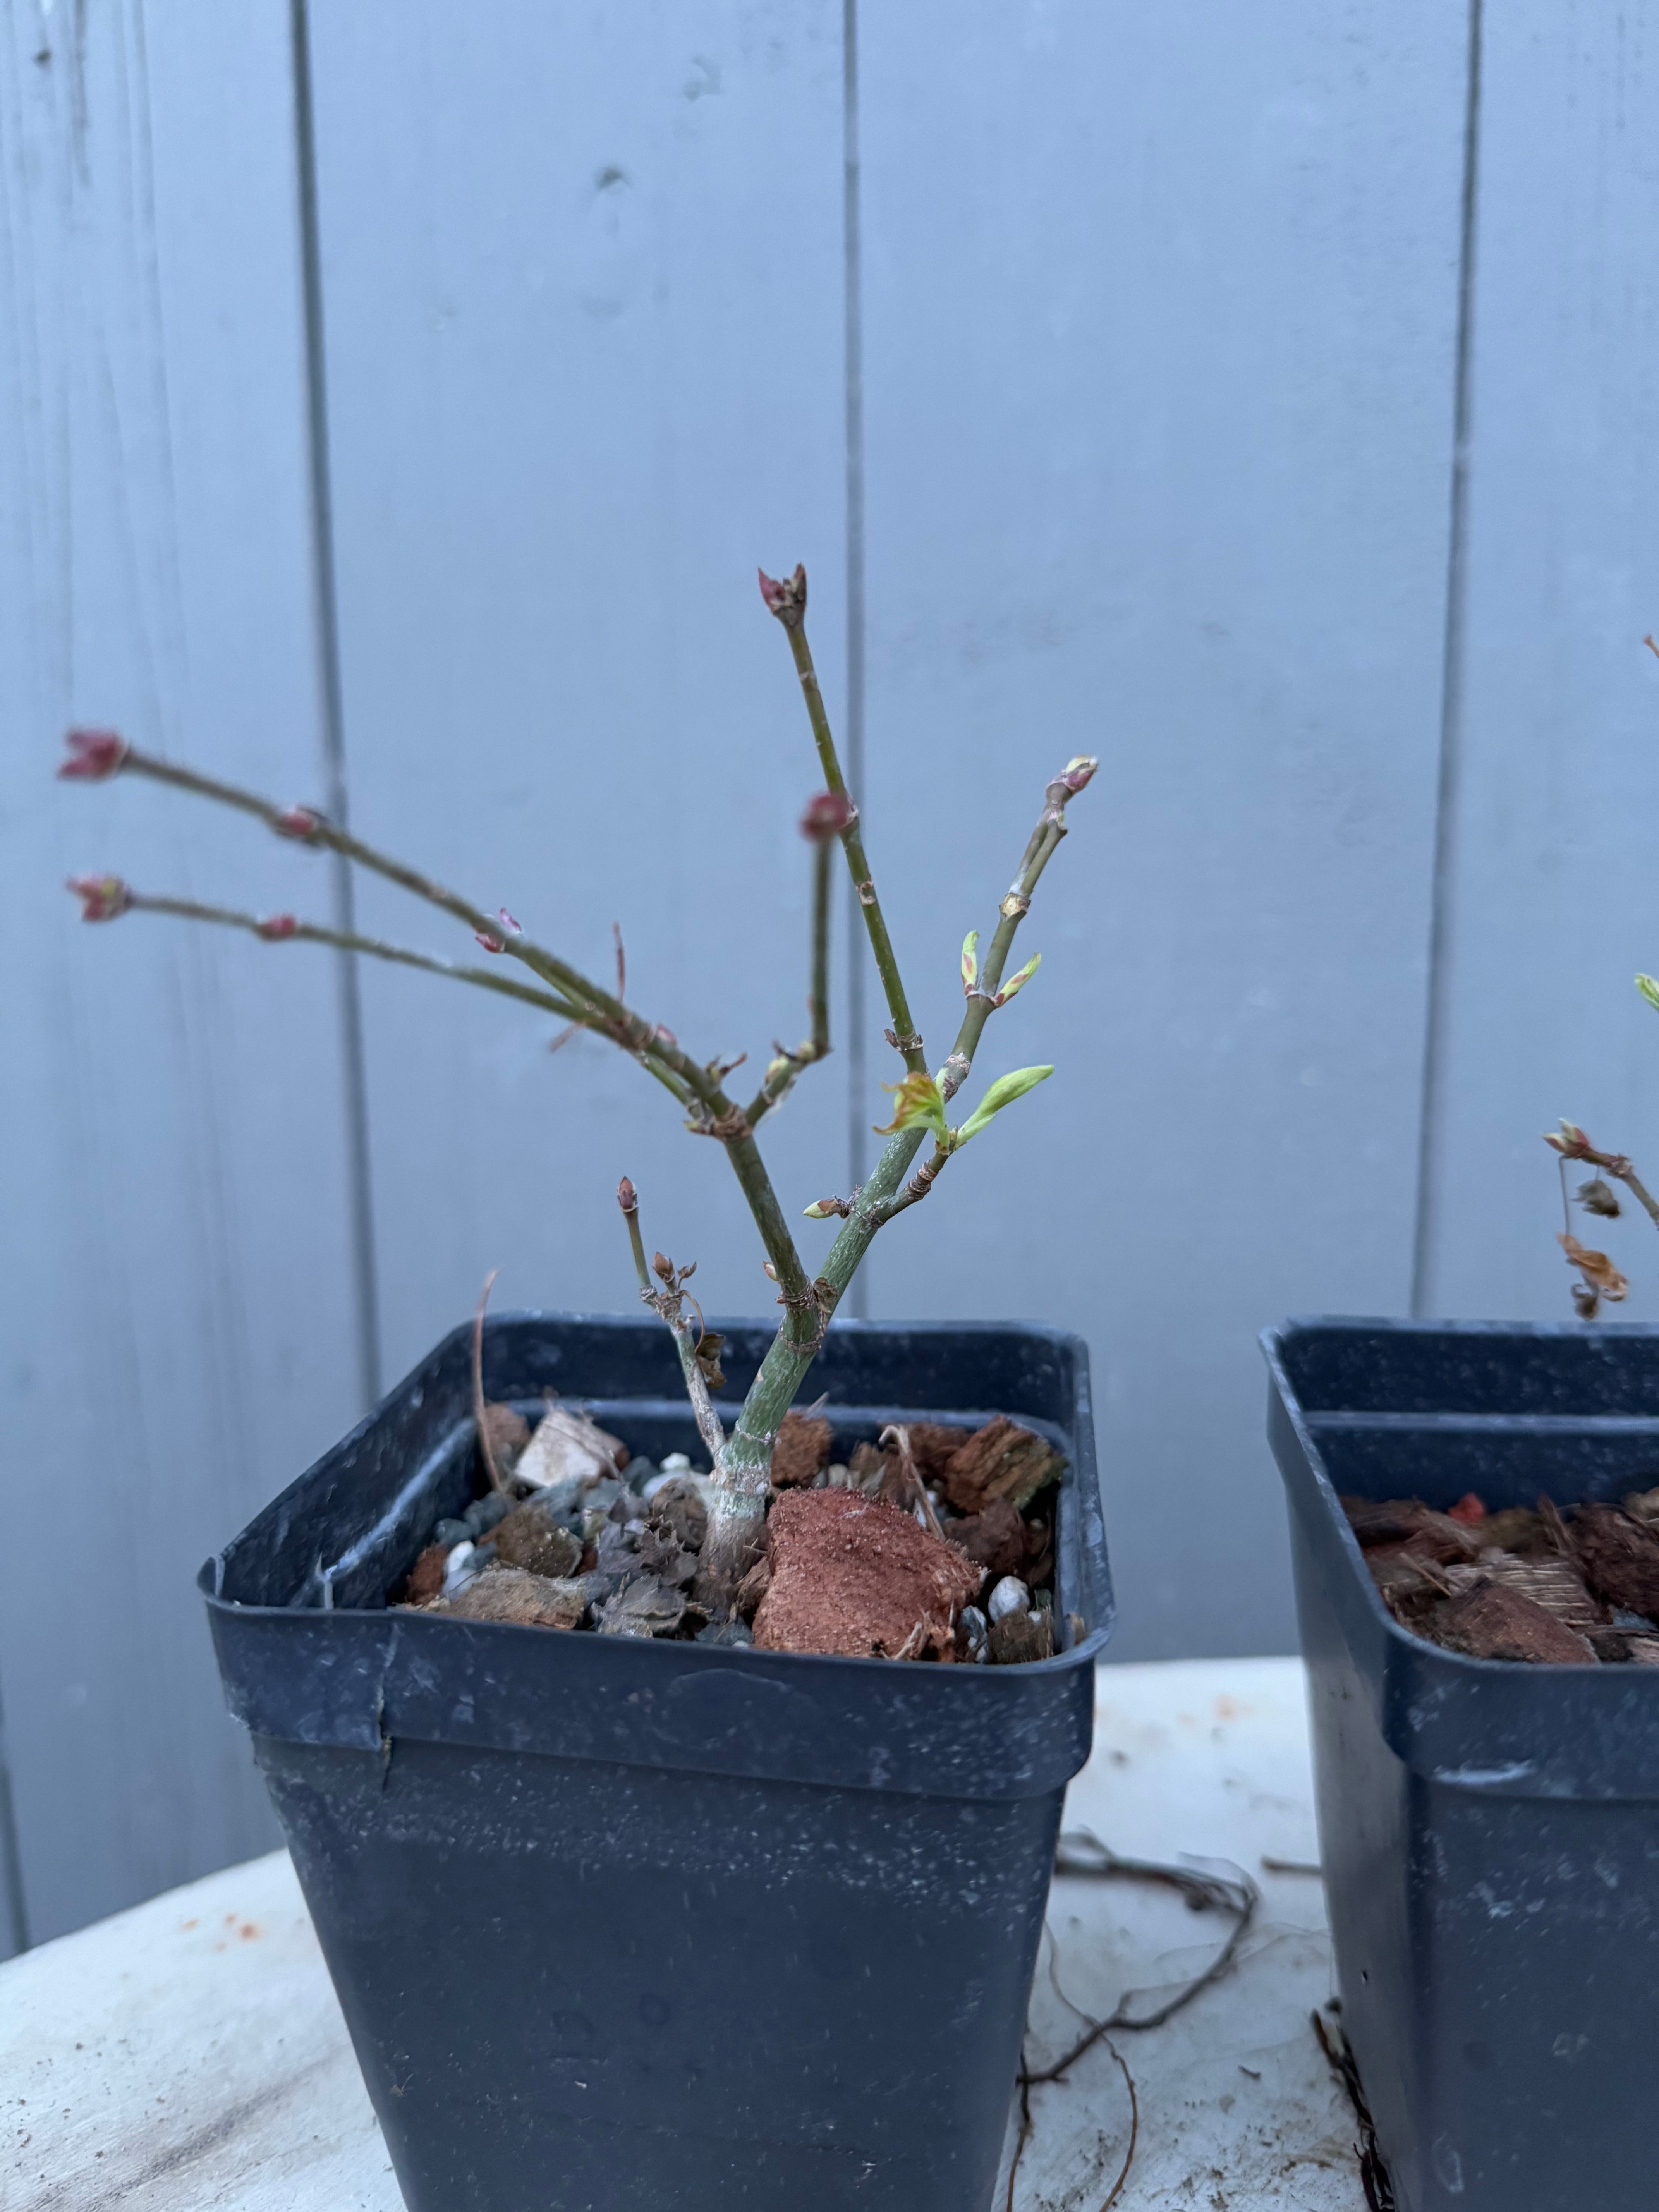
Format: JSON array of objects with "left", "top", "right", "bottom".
[{"left": 1343, "top": 1489, "right": 1659, "bottom": 1666}]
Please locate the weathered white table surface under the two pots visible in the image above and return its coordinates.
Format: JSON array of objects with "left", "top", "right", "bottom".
[{"left": 0, "top": 1659, "right": 1365, "bottom": 2212}]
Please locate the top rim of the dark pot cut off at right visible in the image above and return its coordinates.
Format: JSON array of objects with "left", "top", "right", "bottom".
[{"left": 1259, "top": 1314, "right": 1659, "bottom": 1699}]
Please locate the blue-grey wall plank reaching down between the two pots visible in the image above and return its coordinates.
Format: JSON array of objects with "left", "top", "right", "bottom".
[{"left": 860, "top": 0, "right": 1464, "bottom": 1659}]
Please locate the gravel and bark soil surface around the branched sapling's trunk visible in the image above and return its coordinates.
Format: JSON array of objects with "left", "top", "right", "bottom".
[{"left": 389, "top": 1402, "right": 1066, "bottom": 1666}]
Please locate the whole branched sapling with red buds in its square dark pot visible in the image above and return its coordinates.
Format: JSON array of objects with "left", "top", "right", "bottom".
[{"left": 64, "top": 568, "right": 1113, "bottom": 2212}]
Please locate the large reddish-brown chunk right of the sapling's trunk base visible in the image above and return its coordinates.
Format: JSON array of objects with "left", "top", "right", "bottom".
[{"left": 754, "top": 1489, "right": 982, "bottom": 1659}]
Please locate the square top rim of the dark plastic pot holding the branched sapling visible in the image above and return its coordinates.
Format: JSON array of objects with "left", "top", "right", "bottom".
[{"left": 197, "top": 1307, "right": 1117, "bottom": 1697}]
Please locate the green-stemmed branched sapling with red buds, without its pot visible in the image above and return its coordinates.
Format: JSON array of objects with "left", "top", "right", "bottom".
[{"left": 60, "top": 568, "right": 1097, "bottom": 1617}]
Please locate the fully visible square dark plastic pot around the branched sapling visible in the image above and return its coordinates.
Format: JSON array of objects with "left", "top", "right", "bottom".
[{"left": 204, "top": 1314, "right": 1113, "bottom": 2212}]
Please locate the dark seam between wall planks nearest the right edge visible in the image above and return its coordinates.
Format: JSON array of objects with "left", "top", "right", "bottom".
[{"left": 1411, "top": 0, "right": 1484, "bottom": 1318}]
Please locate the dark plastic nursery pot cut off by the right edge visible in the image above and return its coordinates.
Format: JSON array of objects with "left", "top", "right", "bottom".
[{"left": 1265, "top": 1321, "right": 1659, "bottom": 2212}]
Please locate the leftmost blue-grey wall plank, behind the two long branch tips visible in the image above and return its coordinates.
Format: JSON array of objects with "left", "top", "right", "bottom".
[{"left": 0, "top": 0, "right": 354, "bottom": 1940}]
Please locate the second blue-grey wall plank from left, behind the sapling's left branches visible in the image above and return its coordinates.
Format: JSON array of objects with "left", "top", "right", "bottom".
[{"left": 314, "top": 0, "right": 845, "bottom": 1374}]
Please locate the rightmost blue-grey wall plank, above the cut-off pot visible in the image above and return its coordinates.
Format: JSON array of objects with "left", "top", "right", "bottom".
[{"left": 1427, "top": 0, "right": 1659, "bottom": 1321}]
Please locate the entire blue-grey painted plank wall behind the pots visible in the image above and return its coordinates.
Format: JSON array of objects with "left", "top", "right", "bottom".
[{"left": 0, "top": 0, "right": 1659, "bottom": 1951}]
